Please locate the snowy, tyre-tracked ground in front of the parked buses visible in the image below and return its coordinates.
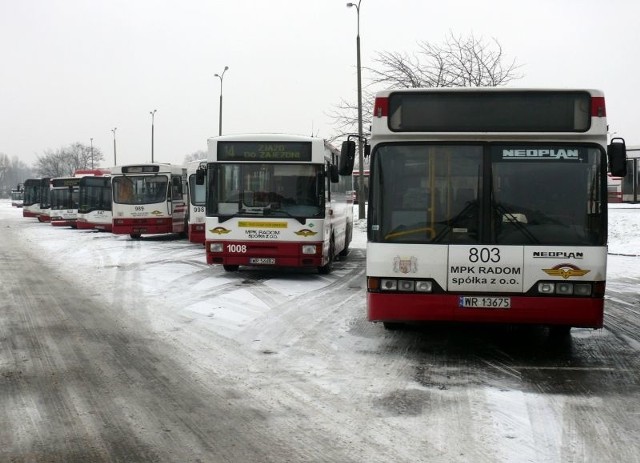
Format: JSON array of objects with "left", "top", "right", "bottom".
[{"left": 0, "top": 200, "right": 640, "bottom": 462}]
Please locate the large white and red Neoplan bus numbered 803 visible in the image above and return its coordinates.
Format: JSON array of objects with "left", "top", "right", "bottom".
[{"left": 341, "top": 88, "right": 626, "bottom": 333}]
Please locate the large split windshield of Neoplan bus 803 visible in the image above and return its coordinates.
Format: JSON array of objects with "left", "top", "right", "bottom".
[{"left": 369, "top": 143, "right": 606, "bottom": 246}]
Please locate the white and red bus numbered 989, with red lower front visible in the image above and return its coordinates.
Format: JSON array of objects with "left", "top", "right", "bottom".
[{"left": 111, "top": 163, "right": 187, "bottom": 239}]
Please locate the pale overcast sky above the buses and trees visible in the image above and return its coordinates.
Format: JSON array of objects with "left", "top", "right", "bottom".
[{"left": 0, "top": 0, "right": 640, "bottom": 166}]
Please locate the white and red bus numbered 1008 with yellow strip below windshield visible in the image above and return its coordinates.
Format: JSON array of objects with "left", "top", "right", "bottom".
[{"left": 200, "top": 134, "right": 353, "bottom": 273}]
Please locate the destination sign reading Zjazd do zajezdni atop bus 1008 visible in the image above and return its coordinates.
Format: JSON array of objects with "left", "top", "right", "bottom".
[{"left": 218, "top": 141, "right": 311, "bottom": 162}]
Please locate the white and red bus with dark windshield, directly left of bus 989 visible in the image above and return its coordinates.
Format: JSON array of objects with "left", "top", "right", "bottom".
[{"left": 76, "top": 175, "right": 112, "bottom": 232}]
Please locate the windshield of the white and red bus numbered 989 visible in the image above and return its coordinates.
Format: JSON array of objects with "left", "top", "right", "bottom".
[{"left": 112, "top": 175, "right": 169, "bottom": 204}]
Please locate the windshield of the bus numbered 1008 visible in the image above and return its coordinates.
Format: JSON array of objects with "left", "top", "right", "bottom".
[{"left": 210, "top": 163, "right": 324, "bottom": 217}]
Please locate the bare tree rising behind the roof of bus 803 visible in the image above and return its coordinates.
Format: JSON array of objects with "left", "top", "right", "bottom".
[{"left": 330, "top": 33, "right": 522, "bottom": 140}]
